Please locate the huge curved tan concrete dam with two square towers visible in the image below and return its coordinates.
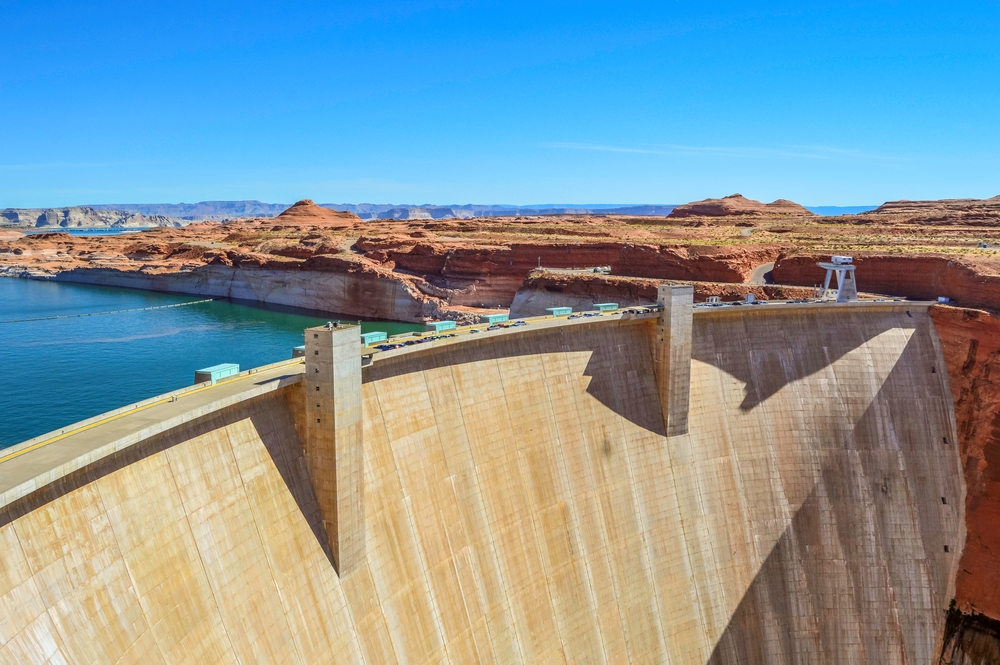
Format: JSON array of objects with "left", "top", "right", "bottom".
[{"left": 0, "top": 286, "right": 965, "bottom": 665}]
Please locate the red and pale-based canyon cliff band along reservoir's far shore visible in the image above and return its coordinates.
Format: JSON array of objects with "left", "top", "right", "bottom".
[{"left": 7, "top": 240, "right": 778, "bottom": 321}]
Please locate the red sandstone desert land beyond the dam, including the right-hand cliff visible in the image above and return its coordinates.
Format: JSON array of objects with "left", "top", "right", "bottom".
[{"left": 7, "top": 196, "right": 1000, "bottom": 663}]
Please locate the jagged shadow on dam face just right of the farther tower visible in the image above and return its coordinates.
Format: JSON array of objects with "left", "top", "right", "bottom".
[{"left": 691, "top": 310, "right": 917, "bottom": 412}]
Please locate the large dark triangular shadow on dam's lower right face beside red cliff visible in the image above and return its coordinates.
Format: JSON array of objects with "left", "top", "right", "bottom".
[{"left": 707, "top": 327, "right": 964, "bottom": 665}]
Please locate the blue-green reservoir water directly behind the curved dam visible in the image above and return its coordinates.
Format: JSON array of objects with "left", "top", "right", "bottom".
[{"left": 0, "top": 278, "right": 422, "bottom": 448}]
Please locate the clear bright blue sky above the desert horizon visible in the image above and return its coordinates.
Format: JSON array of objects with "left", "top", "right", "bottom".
[{"left": 0, "top": 0, "right": 1000, "bottom": 208}]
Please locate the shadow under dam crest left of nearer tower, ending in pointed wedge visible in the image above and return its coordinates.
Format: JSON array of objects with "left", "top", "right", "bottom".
[{"left": 0, "top": 393, "right": 333, "bottom": 566}]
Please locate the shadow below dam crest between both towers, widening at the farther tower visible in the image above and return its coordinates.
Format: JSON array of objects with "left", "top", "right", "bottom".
[{"left": 364, "top": 322, "right": 666, "bottom": 436}]
